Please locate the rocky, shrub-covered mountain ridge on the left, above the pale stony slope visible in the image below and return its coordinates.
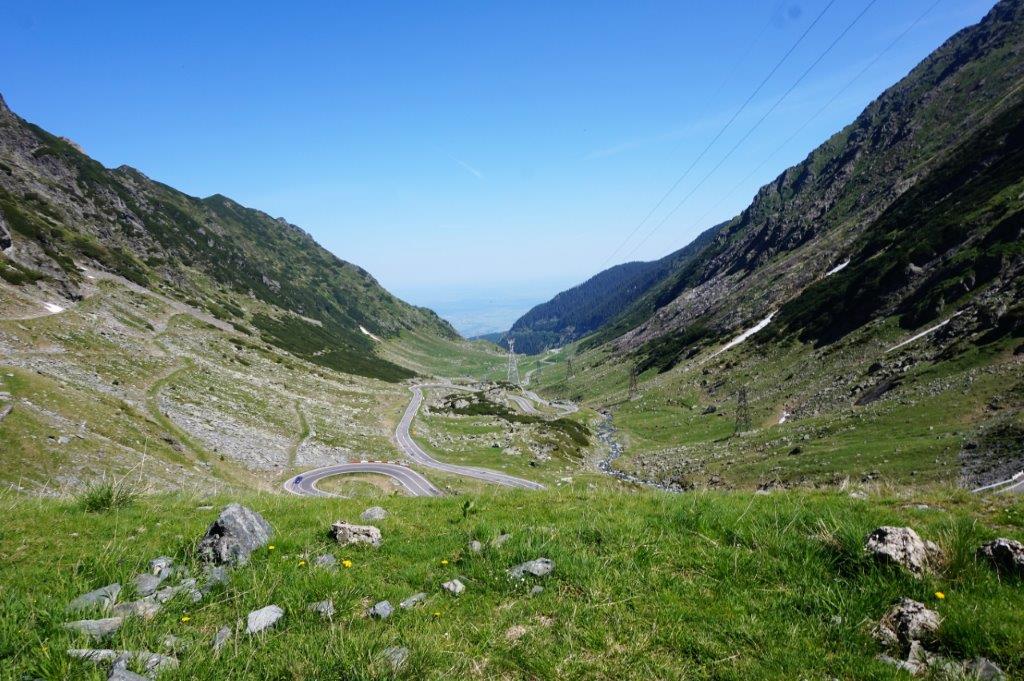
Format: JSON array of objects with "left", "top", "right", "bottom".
[{"left": 0, "top": 98, "right": 457, "bottom": 379}]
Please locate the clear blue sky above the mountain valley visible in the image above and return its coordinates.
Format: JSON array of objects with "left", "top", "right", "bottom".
[{"left": 0, "top": 0, "right": 992, "bottom": 331}]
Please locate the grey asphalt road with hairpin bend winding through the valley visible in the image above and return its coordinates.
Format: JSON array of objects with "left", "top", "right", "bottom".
[{"left": 284, "top": 383, "right": 544, "bottom": 497}]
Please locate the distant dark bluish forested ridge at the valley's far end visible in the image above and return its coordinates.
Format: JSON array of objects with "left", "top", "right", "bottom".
[{"left": 502, "top": 225, "right": 722, "bottom": 354}]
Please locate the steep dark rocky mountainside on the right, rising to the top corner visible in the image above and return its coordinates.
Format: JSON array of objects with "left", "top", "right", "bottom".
[{"left": 591, "top": 0, "right": 1024, "bottom": 369}]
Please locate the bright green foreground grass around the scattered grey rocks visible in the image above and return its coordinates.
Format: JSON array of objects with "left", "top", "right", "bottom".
[{"left": 0, "top": 487, "right": 1024, "bottom": 679}]
